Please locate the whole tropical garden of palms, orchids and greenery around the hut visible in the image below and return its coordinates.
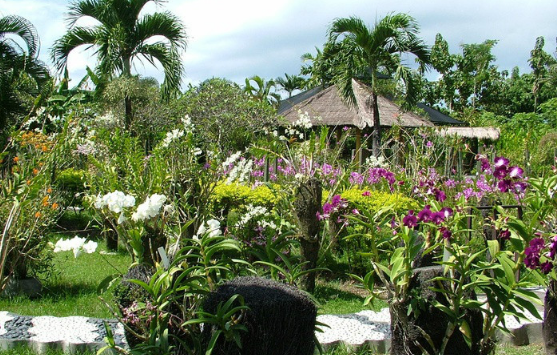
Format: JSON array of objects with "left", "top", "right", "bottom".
[{"left": 0, "top": 0, "right": 557, "bottom": 354}]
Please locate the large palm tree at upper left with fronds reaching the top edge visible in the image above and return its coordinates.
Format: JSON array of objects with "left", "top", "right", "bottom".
[{"left": 52, "top": 0, "right": 187, "bottom": 129}]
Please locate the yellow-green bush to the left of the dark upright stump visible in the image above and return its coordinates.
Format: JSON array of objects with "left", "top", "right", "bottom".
[{"left": 210, "top": 182, "right": 278, "bottom": 211}]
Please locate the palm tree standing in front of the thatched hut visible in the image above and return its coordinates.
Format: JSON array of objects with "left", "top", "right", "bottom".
[{"left": 329, "top": 14, "right": 429, "bottom": 156}]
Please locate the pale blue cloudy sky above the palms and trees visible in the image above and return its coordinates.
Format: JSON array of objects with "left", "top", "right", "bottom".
[{"left": 0, "top": 0, "right": 557, "bottom": 89}]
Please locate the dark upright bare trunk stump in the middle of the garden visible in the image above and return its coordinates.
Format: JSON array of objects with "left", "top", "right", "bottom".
[{"left": 294, "top": 178, "right": 322, "bottom": 292}]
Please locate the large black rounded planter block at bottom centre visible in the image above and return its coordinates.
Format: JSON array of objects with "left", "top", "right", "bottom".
[{"left": 203, "top": 277, "right": 317, "bottom": 355}]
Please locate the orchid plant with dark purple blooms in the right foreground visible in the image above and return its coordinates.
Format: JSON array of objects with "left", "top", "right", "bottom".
[{"left": 347, "top": 158, "right": 543, "bottom": 354}]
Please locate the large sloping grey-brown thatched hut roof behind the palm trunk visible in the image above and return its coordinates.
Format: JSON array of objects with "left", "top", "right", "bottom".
[{"left": 278, "top": 80, "right": 433, "bottom": 128}]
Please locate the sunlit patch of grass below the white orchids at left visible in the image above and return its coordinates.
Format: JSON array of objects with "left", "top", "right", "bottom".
[{"left": 0, "top": 238, "right": 131, "bottom": 318}]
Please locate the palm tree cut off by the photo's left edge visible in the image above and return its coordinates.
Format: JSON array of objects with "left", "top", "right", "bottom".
[{"left": 0, "top": 16, "right": 50, "bottom": 135}]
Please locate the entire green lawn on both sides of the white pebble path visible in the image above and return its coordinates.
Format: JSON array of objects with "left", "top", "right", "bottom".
[{"left": 0, "top": 239, "right": 544, "bottom": 355}]
